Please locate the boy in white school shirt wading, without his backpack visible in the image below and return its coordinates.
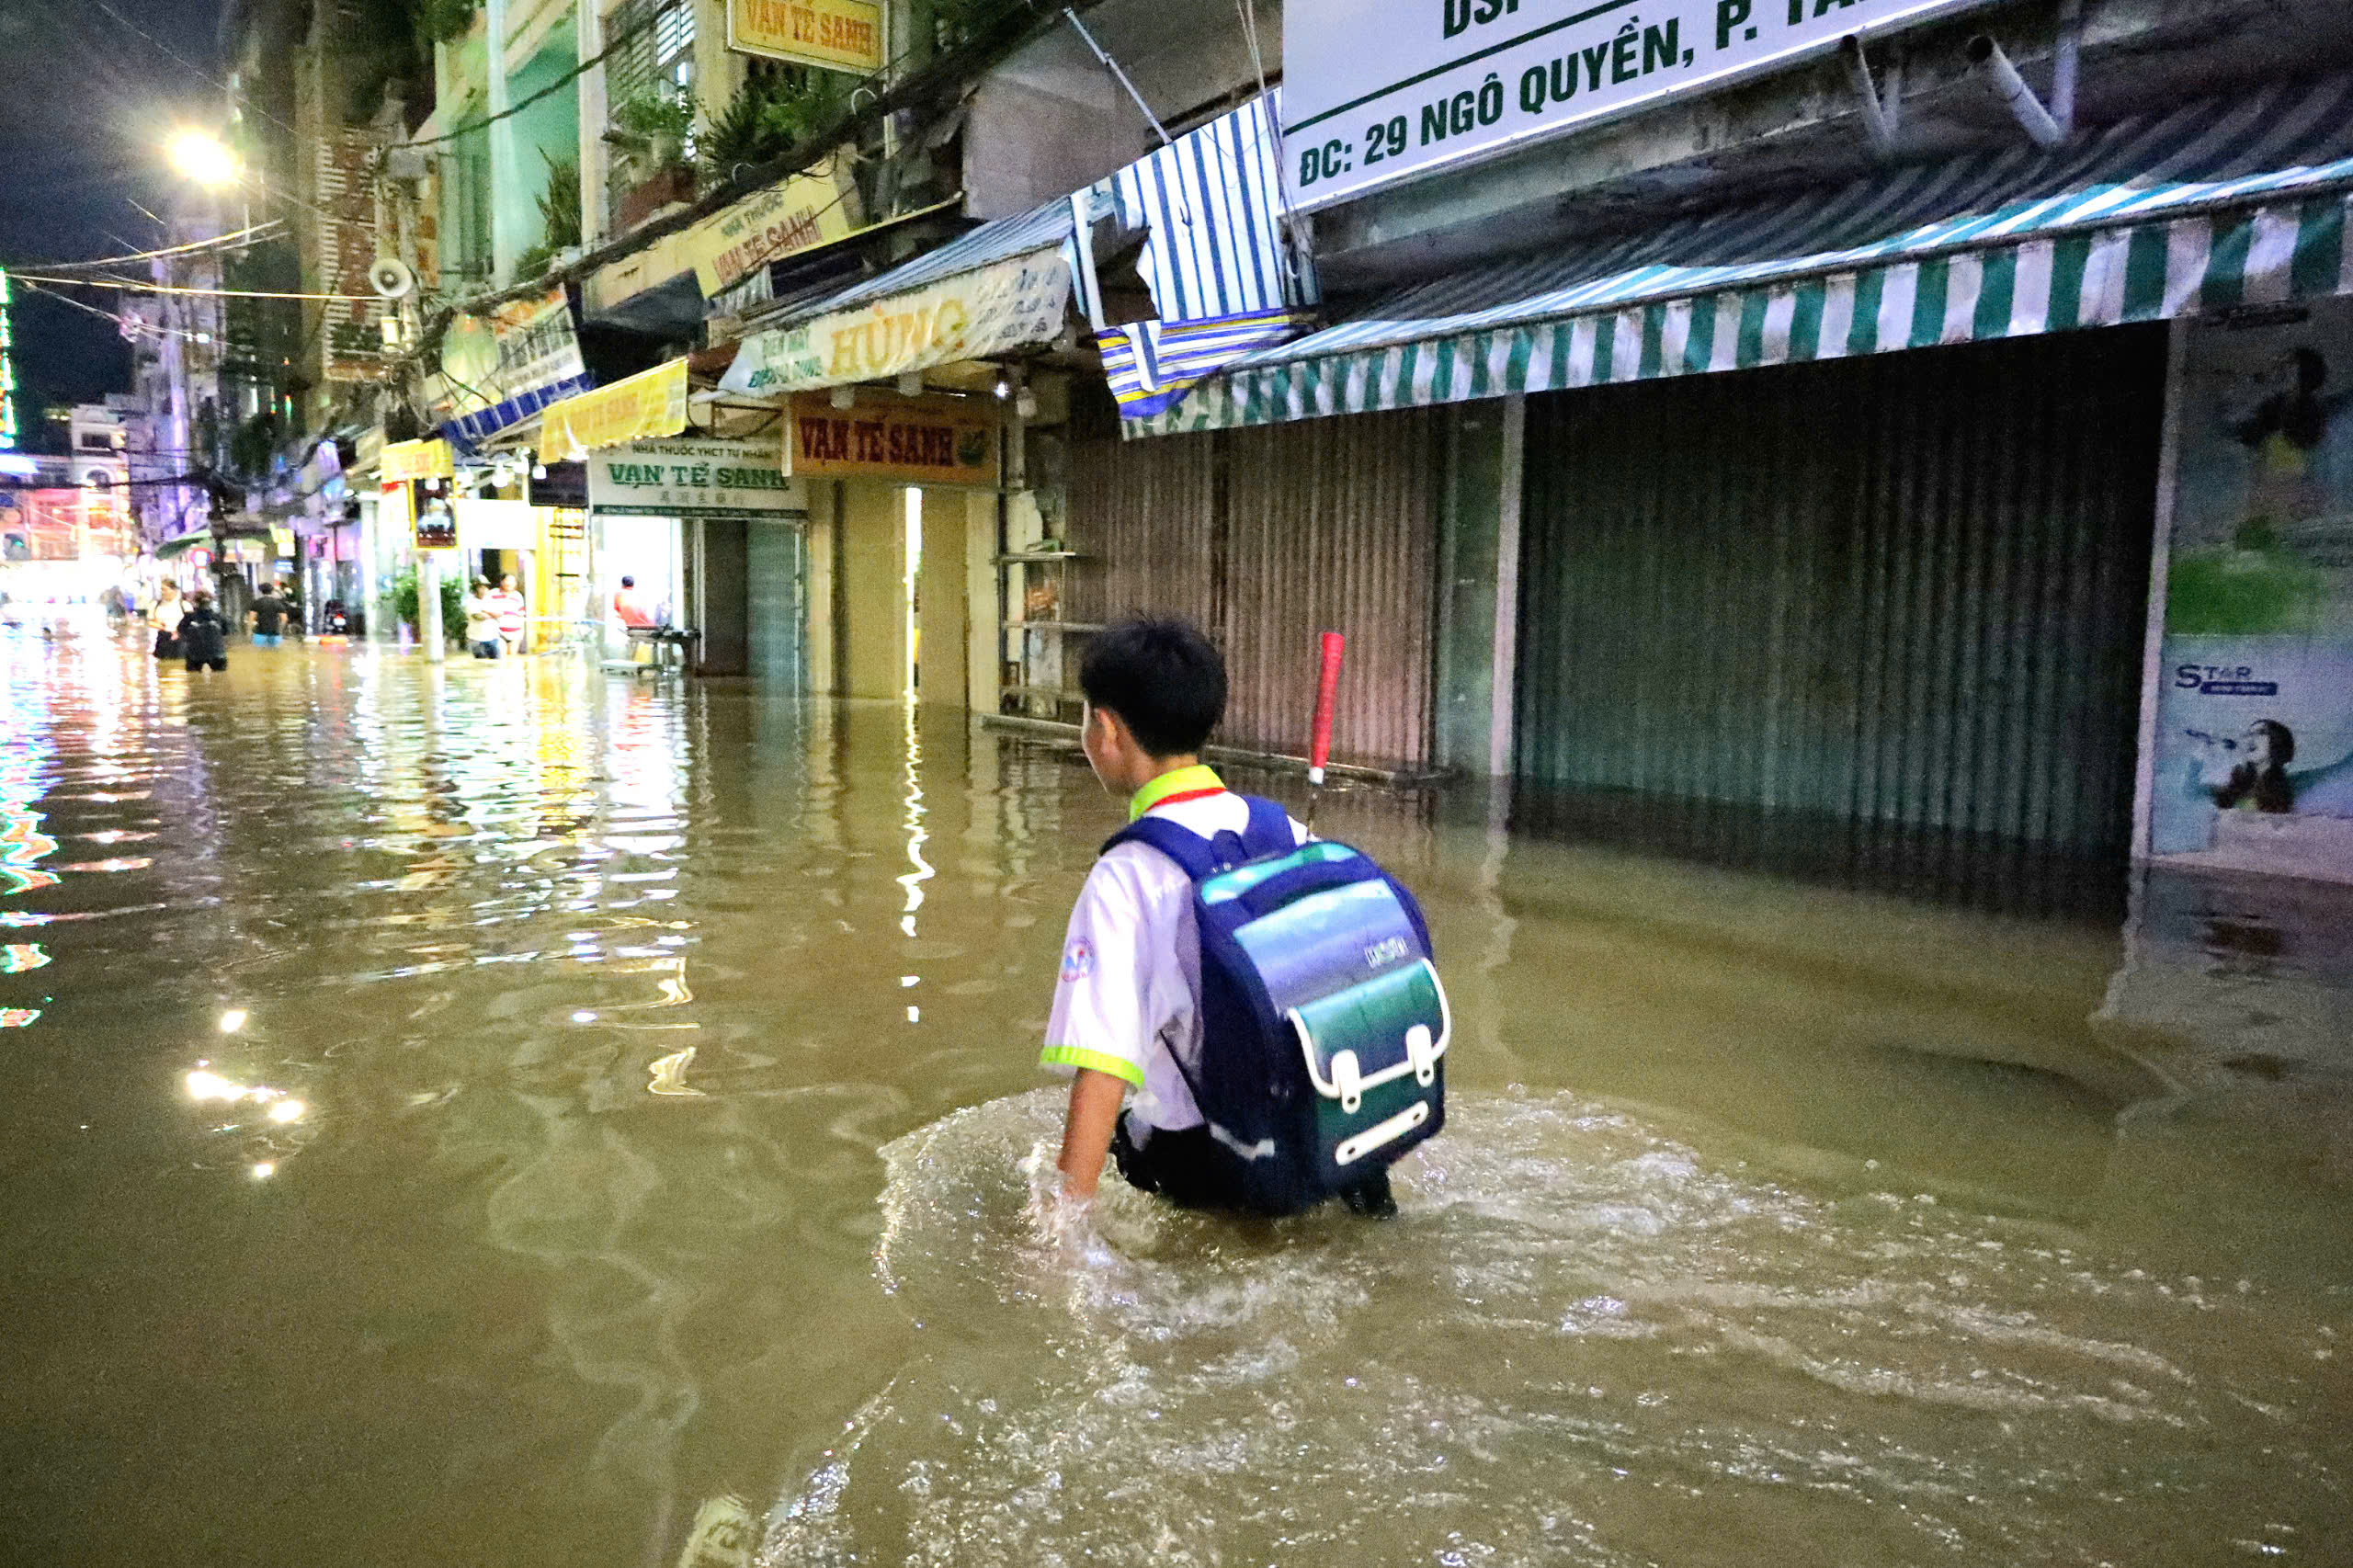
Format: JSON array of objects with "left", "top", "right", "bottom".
[{"left": 1038, "top": 619, "right": 1395, "bottom": 1215}]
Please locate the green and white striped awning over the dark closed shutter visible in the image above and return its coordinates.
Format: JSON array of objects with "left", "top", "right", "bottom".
[{"left": 1130, "top": 78, "right": 2353, "bottom": 436}]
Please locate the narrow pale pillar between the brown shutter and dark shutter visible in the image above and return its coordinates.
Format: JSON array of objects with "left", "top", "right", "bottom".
[{"left": 1438, "top": 398, "right": 1527, "bottom": 777}]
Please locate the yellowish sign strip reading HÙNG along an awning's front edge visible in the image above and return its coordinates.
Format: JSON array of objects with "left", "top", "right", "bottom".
[{"left": 720, "top": 250, "right": 1071, "bottom": 395}]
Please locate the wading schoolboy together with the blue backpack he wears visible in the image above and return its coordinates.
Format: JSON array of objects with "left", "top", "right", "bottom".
[{"left": 1040, "top": 621, "right": 1447, "bottom": 1215}]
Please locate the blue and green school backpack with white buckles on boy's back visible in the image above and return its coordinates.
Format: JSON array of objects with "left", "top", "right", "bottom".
[{"left": 1104, "top": 796, "right": 1452, "bottom": 1215}]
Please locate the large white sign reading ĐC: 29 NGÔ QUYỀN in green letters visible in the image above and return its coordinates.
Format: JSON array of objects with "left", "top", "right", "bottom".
[{"left": 1282, "top": 0, "right": 1988, "bottom": 207}]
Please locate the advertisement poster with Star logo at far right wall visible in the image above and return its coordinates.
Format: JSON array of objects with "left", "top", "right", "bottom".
[{"left": 2148, "top": 299, "right": 2353, "bottom": 881}]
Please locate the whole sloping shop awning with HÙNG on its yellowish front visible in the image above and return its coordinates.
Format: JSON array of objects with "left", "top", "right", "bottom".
[{"left": 720, "top": 198, "right": 1071, "bottom": 398}]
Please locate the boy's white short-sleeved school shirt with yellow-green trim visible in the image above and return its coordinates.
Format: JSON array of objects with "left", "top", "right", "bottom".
[{"left": 1038, "top": 767, "right": 1308, "bottom": 1132}]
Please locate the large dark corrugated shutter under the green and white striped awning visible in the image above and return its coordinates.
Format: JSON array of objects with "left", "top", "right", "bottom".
[{"left": 1518, "top": 327, "right": 2165, "bottom": 902}]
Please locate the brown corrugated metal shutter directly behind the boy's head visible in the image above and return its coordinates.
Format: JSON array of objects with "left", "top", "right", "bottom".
[{"left": 1068, "top": 410, "right": 1442, "bottom": 767}]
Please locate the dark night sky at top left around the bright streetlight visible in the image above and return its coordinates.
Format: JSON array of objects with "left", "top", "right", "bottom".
[{"left": 0, "top": 0, "right": 226, "bottom": 435}]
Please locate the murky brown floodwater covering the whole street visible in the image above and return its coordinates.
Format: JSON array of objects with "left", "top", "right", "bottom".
[{"left": 0, "top": 629, "right": 2353, "bottom": 1568}]
